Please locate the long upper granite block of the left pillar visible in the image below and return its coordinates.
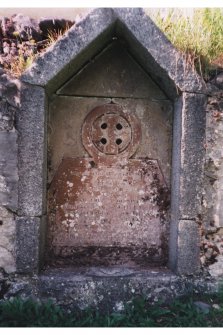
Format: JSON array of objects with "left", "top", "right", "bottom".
[{"left": 17, "top": 85, "right": 46, "bottom": 216}]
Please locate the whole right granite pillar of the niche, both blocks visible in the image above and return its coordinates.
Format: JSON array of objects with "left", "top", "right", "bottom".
[{"left": 169, "top": 93, "right": 207, "bottom": 275}]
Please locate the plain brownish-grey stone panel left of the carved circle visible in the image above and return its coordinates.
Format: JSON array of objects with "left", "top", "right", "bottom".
[{"left": 47, "top": 96, "right": 111, "bottom": 183}]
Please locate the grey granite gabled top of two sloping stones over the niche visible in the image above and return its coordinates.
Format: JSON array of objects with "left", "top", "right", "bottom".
[{"left": 21, "top": 8, "right": 206, "bottom": 99}]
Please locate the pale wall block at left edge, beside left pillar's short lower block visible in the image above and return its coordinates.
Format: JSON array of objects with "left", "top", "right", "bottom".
[{"left": 0, "top": 207, "right": 16, "bottom": 274}]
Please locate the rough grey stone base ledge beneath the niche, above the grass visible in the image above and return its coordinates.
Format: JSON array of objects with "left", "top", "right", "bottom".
[{"left": 0, "top": 267, "right": 218, "bottom": 312}]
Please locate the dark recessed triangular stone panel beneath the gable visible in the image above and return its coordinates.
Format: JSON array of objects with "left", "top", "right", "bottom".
[{"left": 57, "top": 41, "right": 166, "bottom": 99}]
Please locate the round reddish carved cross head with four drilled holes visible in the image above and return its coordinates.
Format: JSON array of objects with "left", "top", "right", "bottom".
[{"left": 82, "top": 104, "right": 141, "bottom": 158}]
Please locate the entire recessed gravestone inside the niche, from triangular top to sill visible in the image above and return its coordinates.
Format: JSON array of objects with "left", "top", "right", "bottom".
[{"left": 47, "top": 41, "right": 172, "bottom": 266}]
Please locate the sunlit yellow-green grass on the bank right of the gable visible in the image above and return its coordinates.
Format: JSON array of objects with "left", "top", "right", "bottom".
[{"left": 149, "top": 8, "right": 223, "bottom": 80}]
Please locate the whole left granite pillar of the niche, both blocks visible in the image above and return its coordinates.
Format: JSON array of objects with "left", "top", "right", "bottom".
[{"left": 16, "top": 84, "right": 47, "bottom": 273}]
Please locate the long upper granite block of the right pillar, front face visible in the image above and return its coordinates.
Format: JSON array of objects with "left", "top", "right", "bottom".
[{"left": 179, "top": 93, "right": 207, "bottom": 219}]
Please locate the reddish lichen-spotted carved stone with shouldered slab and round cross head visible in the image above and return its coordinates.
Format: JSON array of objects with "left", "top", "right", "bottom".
[{"left": 48, "top": 104, "right": 169, "bottom": 264}]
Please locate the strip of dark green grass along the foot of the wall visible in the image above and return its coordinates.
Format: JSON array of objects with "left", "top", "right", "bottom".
[{"left": 0, "top": 292, "right": 223, "bottom": 327}]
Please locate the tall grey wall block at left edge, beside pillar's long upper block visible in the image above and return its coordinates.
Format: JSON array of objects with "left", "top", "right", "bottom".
[{"left": 0, "top": 131, "right": 18, "bottom": 211}]
